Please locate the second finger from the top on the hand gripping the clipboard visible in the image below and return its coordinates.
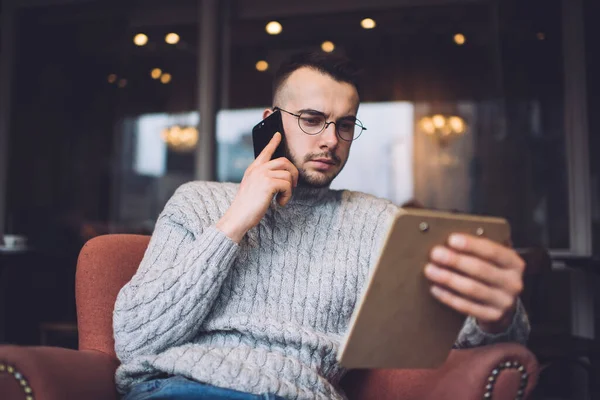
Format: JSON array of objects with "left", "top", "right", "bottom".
[{"left": 431, "top": 246, "right": 523, "bottom": 294}]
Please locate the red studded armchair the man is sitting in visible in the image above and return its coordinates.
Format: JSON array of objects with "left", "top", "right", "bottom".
[{"left": 0, "top": 235, "right": 538, "bottom": 400}]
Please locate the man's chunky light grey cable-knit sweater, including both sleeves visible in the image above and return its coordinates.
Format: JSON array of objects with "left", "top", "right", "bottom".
[{"left": 113, "top": 182, "right": 529, "bottom": 399}]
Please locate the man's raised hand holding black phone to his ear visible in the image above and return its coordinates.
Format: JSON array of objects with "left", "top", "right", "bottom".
[{"left": 216, "top": 132, "right": 298, "bottom": 243}]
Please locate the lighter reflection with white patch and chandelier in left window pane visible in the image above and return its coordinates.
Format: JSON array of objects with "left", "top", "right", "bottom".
[{"left": 111, "top": 112, "right": 200, "bottom": 233}]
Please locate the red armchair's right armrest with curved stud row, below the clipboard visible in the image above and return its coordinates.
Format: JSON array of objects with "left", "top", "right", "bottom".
[{"left": 343, "top": 343, "right": 539, "bottom": 400}]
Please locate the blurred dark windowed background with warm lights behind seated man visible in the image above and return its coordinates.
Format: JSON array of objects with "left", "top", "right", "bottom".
[{"left": 0, "top": 0, "right": 600, "bottom": 399}]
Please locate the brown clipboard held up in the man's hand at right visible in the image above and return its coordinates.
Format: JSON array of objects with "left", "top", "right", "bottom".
[{"left": 337, "top": 209, "right": 510, "bottom": 369}]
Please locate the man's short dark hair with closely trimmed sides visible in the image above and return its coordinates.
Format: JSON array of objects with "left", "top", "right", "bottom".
[{"left": 273, "top": 51, "right": 361, "bottom": 103}]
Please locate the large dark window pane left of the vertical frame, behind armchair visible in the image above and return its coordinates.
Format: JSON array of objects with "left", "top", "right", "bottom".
[{"left": 8, "top": 0, "right": 198, "bottom": 245}]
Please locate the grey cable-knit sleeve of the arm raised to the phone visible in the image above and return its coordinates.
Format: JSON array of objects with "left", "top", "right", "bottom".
[{"left": 113, "top": 186, "right": 238, "bottom": 362}]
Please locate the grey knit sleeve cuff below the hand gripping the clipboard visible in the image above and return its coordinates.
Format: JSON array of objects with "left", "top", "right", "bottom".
[{"left": 454, "top": 299, "right": 531, "bottom": 349}]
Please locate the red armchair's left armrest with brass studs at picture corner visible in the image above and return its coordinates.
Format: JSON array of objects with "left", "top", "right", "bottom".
[{"left": 0, "top": 345, "right": 119, "bottom": 400}]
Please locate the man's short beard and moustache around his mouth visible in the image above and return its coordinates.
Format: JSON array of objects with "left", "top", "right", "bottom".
[{"left": 284, "top": 143, "right": 346, "bottom": 189}]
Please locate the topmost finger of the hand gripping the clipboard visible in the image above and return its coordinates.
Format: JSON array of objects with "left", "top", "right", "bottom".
[{"left": 448, "top": 234, "right": 525, "bottom": 271}]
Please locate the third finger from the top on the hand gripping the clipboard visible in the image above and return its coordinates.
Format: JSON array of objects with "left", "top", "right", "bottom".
[{"left": 425, "top": 264, "right": 514, "bottom": 310}]
